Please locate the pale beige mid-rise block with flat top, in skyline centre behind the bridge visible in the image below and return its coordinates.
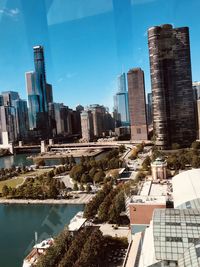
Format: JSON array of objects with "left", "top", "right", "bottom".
[{"left": 81, "top": 110, "right": 94, "bottom": 142}]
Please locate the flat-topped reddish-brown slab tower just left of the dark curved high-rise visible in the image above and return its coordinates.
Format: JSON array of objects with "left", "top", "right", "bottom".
[{"left": 127, "top": 68, "right": 148, "bottom": 141}]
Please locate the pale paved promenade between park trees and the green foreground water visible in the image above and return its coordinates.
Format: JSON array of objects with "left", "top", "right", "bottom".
[{"left": 0, "top": 194, "right": 95, "bottom": 205}]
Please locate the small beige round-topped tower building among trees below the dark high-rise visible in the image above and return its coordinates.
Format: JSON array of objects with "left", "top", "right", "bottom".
[{"left": 151, "top": 158, "right": 167, "bottom": 181}]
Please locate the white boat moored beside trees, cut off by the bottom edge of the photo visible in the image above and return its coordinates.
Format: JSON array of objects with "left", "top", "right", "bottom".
[{"left": 22, "top": 238, "right": 54, "bottom": 267}]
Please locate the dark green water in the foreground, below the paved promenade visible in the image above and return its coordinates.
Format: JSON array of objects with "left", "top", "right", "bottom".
[{"left": 0, "top": 204, "right": 83, "bottom": 267}]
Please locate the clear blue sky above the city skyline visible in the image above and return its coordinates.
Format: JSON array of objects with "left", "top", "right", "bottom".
[{"left": 0, "top": 0, "right": 200, "bottom": 110}]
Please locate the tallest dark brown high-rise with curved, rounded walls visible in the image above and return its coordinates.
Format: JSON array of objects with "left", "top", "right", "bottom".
[{"left": 148, "top": 24, "right": 196, "bottom": 149}]
